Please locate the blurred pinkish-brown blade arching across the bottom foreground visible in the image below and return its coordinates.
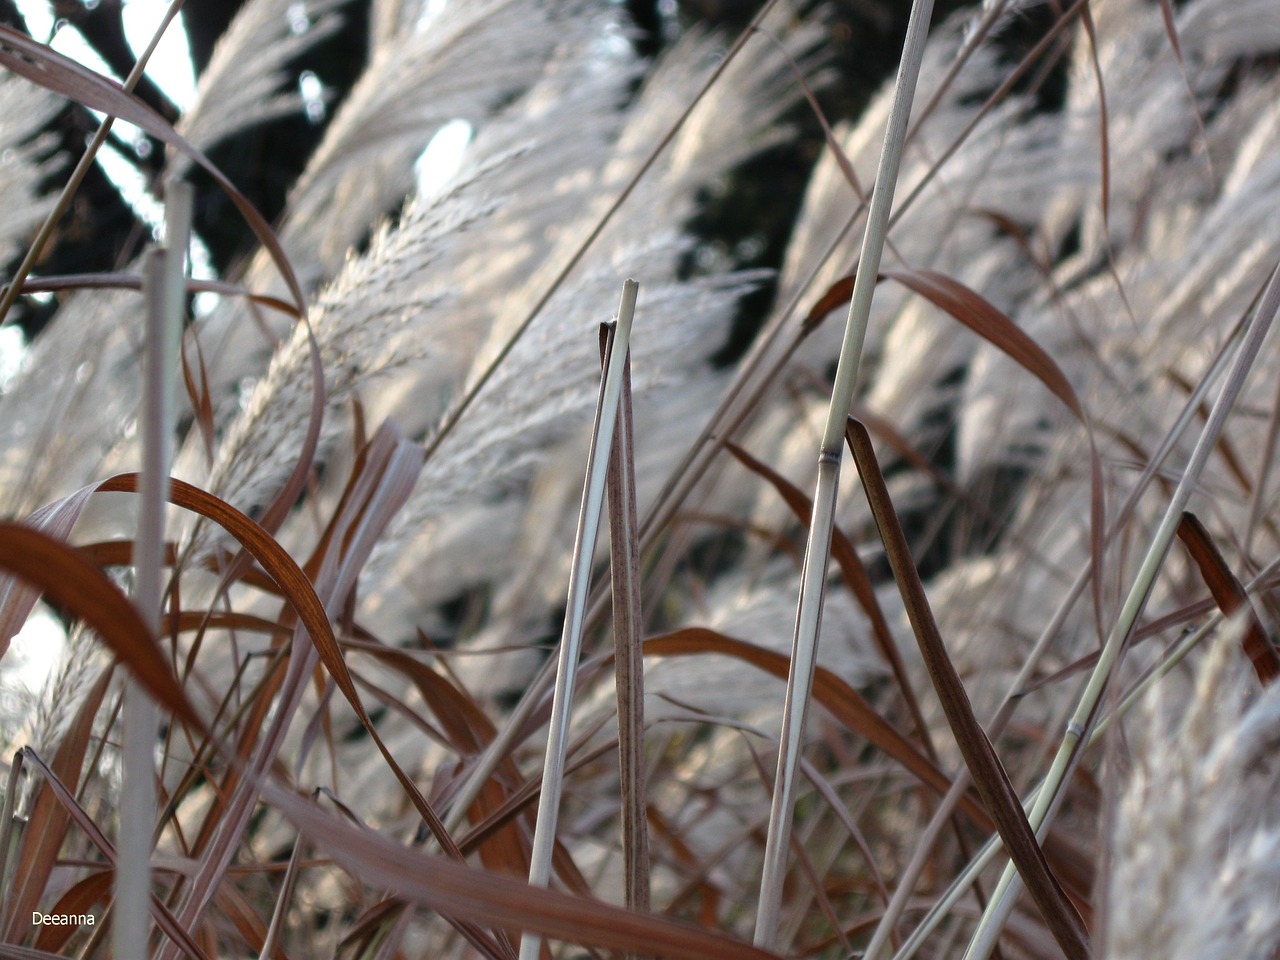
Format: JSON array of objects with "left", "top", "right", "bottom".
[{"left": 269, "top": 787, "right": 776, "bottom": 960}]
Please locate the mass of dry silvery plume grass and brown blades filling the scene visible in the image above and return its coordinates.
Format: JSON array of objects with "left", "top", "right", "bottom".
[{"left": 0, "top": 0, "right": 1280, "bottom": 960}]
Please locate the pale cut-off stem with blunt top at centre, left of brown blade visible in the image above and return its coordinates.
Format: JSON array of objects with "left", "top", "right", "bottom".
[{"left": 520, "top": 280, "right": 640, "bottom": 960}]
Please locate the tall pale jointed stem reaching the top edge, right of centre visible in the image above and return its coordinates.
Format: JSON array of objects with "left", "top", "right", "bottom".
[{"left": 755, "top": 0, "right": 933, "bottom": 950}]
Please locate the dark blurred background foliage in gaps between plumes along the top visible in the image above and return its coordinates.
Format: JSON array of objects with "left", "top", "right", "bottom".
[{"left": 0, "top": 0, "right": 988, "bottom": 350}]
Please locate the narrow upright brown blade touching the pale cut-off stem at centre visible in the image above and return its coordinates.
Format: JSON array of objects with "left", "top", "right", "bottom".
[{"left": 607, "top": 327, "right": 649, "bottom": 913}]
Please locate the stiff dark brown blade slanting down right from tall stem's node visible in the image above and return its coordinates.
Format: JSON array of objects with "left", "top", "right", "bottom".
[{"left": 846, "top": 420, "right": 1089, "bottom": 960}]
